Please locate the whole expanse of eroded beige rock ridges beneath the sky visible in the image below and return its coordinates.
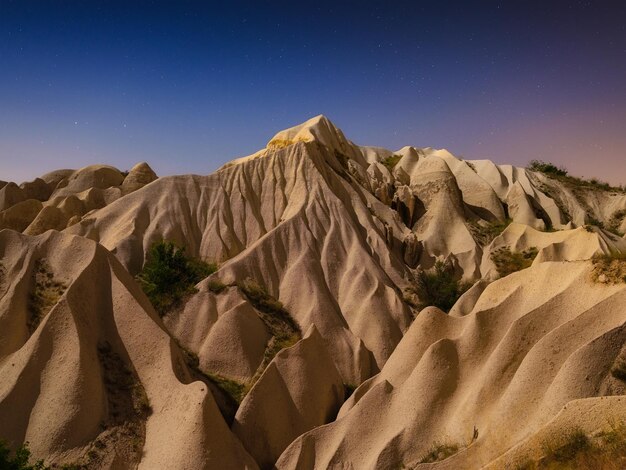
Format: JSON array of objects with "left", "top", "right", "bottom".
[{"left": 0, "top": 116, "right": 626, "bottom": 469}]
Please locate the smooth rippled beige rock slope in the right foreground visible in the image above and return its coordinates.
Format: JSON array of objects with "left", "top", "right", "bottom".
[{"left": 277, "top": 261, "right": 626, "bottom": 469}]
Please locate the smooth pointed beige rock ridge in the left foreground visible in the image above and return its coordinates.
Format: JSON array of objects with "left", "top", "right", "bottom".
[{"left": 0, "top": 230, "right": 256, "bottom": 469}]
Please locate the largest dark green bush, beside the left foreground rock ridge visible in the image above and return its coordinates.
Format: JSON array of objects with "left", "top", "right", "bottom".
[{"left": 137, "top": 241, "right": 217, "bottom": 317}]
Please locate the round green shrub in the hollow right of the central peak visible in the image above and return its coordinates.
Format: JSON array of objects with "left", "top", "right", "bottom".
[{"left": 415, "top": 261, "right": 471, "bottom": 312}]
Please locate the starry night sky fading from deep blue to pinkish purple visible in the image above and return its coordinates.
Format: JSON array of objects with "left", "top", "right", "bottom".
[{"left": 0, "top": 0, "right": 626, "bottom": 183}]
